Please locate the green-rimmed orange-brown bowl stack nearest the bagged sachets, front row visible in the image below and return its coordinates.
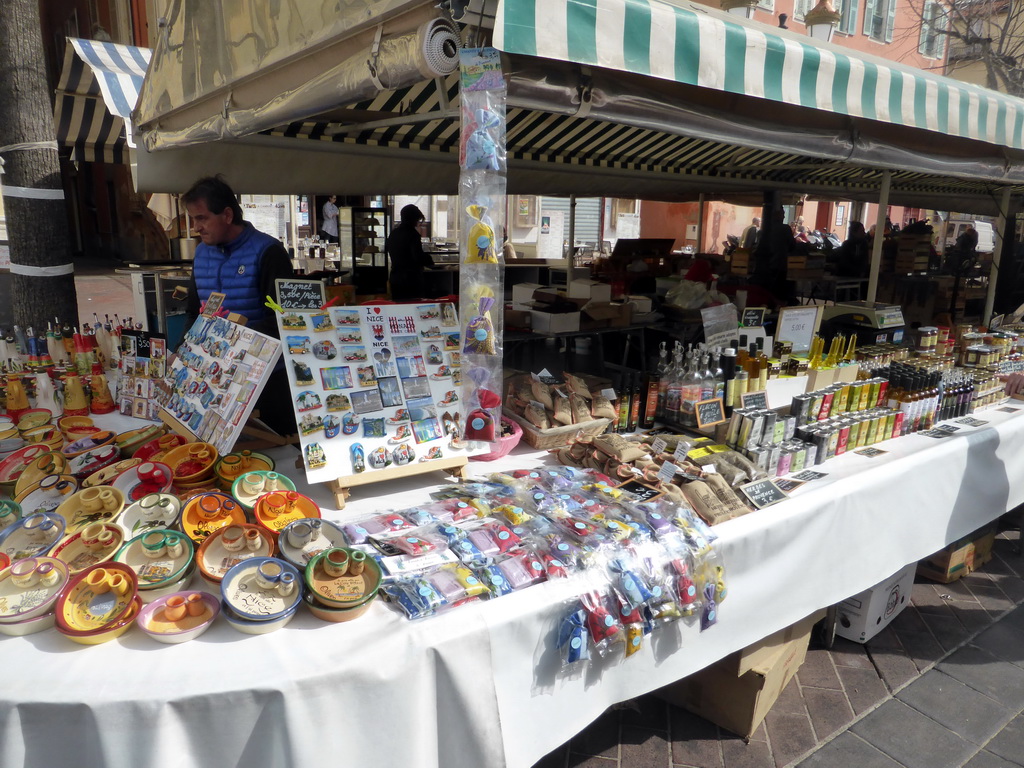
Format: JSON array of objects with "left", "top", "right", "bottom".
[{"left": 303, "top": 547, "right": 383, "bottom": 622}]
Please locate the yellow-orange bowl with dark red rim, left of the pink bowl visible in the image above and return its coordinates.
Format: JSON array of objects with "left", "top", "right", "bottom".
[{"left": 55, "top": 562, "right": 136, "bottom": 633}]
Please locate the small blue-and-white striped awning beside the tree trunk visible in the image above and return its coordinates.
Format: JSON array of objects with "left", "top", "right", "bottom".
[{"left": 53, "top": 38, "right": 151, "bottom": 163}]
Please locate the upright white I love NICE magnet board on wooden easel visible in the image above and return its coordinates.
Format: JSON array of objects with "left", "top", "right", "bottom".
[{"left": 278, "top": 303, "right": 479, "bottom": 509}]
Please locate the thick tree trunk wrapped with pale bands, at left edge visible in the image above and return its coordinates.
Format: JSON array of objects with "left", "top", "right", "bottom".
[{"left": 0, "top": 0, "right": 78, "bottom": 333}]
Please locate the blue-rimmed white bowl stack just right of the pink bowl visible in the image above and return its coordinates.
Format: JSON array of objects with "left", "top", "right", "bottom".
[{"left": 220, "top": 557, "right": 302, "bottom": 635}]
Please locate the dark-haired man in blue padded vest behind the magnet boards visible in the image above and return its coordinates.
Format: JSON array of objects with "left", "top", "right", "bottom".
[{"left": 181, "top": 175, "right": 296, "bottom": 434}]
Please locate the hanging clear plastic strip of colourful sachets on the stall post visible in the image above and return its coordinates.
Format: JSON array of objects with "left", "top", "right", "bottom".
[{"left": 459, "top": 48, "right": 506, "bottom": 450}]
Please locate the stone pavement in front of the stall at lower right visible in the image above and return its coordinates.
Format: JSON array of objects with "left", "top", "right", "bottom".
[{"left": 535, "top": 530, "right": 1024, "bottom": 768}]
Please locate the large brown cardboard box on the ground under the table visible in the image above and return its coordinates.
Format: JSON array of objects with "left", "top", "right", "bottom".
[{"left": 655, "top": 611, "right": 824, "bottom": 738}]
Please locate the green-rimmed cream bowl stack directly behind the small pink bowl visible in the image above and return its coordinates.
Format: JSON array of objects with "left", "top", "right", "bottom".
[{"left": 114, "top": 528, "right": 196, "bottom": 603}]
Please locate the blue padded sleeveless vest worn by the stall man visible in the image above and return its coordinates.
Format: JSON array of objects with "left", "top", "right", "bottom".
[{"left": 193, "top": 221, "right": 280, "bottom": 326}]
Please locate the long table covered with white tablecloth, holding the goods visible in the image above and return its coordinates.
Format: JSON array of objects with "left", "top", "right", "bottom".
[{"left": 0, "top": 409, "right": 1024, "bottom": 768}]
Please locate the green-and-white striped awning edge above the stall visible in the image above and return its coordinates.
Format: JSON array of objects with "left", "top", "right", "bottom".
[{"left": 494, "top": 0, "right": 1024, "bottom": 150}]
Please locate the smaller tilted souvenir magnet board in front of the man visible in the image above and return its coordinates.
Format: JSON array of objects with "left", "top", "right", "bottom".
[{"left": 161, "top": 315, "right": 281, "bottom": 454}]
